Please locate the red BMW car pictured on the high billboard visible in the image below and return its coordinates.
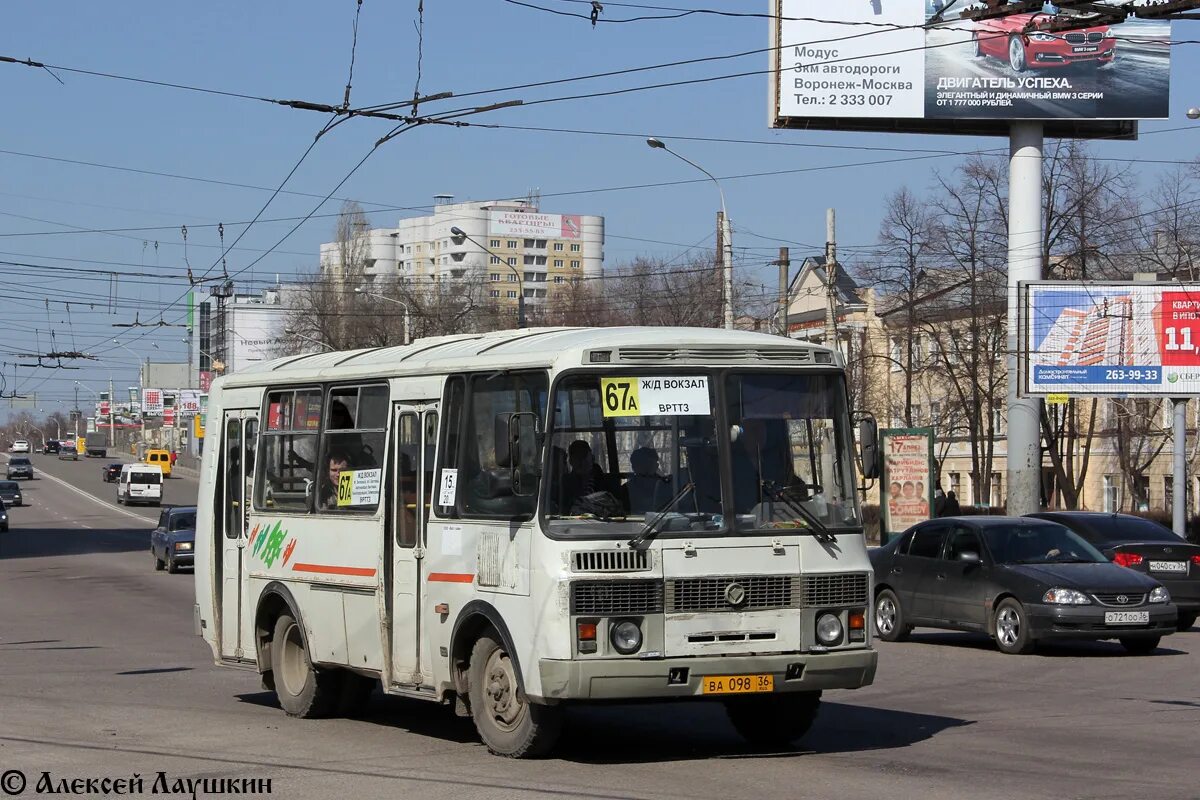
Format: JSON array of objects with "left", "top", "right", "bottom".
[{"left": 971, "top": 13, "right": 1117, "bottom": 72}]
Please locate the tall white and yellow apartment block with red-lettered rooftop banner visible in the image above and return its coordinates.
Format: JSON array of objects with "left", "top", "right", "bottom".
[{"left": 320, "top": 194, "right": 604, "bottom": 314}]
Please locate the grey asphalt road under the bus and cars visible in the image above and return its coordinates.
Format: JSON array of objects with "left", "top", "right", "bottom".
[{"left": 0, "top": 456, "right": 1200, "bottom": 800}]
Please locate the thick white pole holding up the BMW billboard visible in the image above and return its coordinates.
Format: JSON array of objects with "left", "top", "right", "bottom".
[{"left": 1006, "top": 121, "right": 1043, "bottom": 516}]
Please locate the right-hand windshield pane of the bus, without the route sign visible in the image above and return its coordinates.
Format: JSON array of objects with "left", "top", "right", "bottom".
[{"left": 725, "top": 373, "right": 860, "bottom": 530}]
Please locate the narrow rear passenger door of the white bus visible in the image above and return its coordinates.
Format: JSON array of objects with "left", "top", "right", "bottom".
[{"left": 218, "top": 411, "right": 258, "bottom": 661}]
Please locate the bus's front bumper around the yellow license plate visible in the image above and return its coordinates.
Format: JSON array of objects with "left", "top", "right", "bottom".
[{"left": 530, "top": 649, "right": 878, "bottom": 700}]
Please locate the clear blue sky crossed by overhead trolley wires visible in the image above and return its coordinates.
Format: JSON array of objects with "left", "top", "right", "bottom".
[{"left": 0, "top": 0, "right": 1200, "bottom": 413}]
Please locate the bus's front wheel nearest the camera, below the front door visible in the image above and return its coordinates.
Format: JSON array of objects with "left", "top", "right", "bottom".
[{"left": 467, "top": 630, "right": 563, "bottom": 758}]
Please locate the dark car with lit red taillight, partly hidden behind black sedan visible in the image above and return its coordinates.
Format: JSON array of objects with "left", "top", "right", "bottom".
[{"left": 1030, "top": 511, "right": 1200, "bottom": 631}]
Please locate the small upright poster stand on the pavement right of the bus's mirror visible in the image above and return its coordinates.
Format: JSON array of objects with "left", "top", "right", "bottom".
[{"left": 880, "top": 428, "right": 934, "bottom": 543}]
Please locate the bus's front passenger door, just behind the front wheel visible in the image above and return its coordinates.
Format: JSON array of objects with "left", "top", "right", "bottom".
[{"left": 390, "top": 403, "right": 438, "bottom": 686}]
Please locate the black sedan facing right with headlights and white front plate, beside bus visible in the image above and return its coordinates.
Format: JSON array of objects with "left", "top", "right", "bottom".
[{"left": 871, "top": 517, "right": 1178, "bottom": 654}]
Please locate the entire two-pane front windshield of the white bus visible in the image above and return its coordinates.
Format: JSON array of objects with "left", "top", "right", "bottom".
[{"left": 542, "top": 371, "right": 859, "bottom": 536}]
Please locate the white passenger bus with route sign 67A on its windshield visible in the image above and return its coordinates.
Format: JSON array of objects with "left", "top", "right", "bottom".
[{"left": 196, "top": 327, "right": 876, "bottom": 756}]
